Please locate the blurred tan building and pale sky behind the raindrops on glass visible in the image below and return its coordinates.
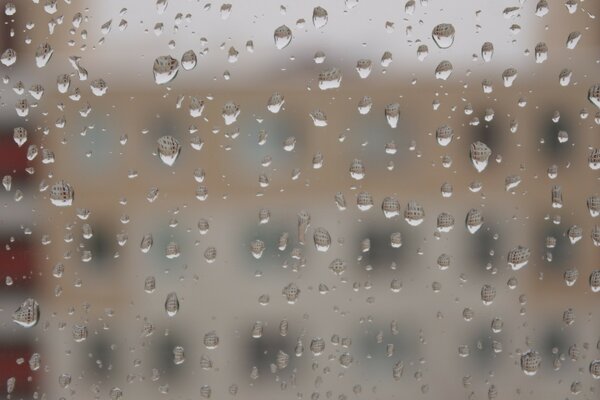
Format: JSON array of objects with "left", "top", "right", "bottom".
[{"left": 0, "top": 0, "right": 600, "bottom": 400}]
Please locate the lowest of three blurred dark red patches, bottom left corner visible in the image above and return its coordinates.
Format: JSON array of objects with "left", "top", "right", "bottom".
[{"left": 0, "top": 343, "right": 37, "bottom": 395}]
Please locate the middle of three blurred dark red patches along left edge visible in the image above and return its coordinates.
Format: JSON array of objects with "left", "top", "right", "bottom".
[{"left": 0, "top": 238, "right": 34, "bottom": 290}]
